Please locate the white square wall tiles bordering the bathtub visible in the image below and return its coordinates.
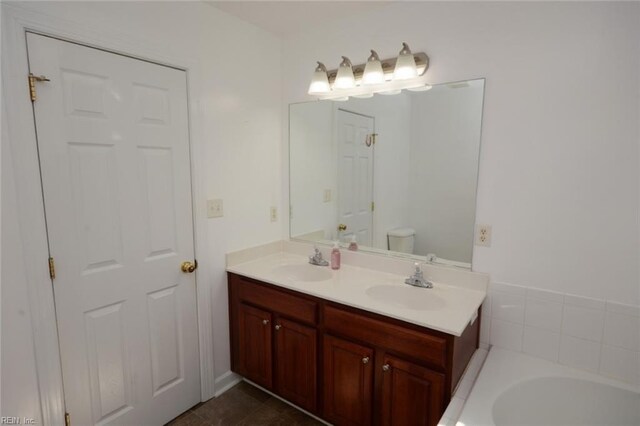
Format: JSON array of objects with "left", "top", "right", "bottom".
[{"left": 488, "top": 282, "right": 640, "bottom": 385}]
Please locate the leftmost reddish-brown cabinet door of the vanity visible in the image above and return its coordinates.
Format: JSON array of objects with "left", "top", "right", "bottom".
[{"left": 237, "top": 303, "right": 272, "bottom": 389}]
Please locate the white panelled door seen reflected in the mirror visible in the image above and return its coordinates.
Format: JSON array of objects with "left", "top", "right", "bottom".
[{"left": 338, "top": 110, "right": 374, "bottom": 246}]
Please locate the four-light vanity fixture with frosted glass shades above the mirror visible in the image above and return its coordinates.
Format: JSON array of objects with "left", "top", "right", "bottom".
[{"left": 308, "top": 43, "right": 431, "bottom": 101}]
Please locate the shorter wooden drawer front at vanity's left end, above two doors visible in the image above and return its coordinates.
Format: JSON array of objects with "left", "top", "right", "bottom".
[{"left": 232, "top": 276, "right": 318, "bottom": 324}]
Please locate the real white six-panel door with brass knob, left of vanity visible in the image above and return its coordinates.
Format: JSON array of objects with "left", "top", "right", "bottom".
[{"left": 27, "top": 33, "right": 200, "bottom": 425}]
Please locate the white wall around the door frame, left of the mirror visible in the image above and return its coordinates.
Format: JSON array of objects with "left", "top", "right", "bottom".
[{"left": 2, "top": 2, "right": 283, "bottom": 418}]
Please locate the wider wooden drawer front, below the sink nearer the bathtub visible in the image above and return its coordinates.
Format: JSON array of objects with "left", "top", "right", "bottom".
[{"left": 324, "top": 305, "right": 447, "bottom": 368}]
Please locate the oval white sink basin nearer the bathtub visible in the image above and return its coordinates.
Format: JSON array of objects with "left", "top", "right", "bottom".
[{"left": 366, "top": 285, "right": 445, "bottom": 311}]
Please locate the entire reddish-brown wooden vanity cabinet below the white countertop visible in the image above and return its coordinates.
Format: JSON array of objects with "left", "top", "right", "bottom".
[{"left": 229, "top": 273, "right": 480, "bottom": 426}]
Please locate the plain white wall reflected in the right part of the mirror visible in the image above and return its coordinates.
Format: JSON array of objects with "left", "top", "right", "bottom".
[{"left": 408, "top": 80, "right": 484, "bottom": 263}]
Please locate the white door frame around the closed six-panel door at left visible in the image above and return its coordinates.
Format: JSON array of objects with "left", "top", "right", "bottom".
[{"left": 0, "top": 3, "right": 215, "bottom": 425}]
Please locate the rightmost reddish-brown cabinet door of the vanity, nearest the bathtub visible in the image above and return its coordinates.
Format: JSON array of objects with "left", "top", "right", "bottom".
[{"left": 378, "top": 355, "right": 444, "bottom": 426}]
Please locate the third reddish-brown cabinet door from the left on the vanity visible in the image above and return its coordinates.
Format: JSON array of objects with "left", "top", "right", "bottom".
[{"left": 323, "top": 336, "right": 374, "bottom": 425}]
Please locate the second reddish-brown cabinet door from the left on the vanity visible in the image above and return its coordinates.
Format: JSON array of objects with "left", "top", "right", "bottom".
[{"left": 274, "top": 319, "right": 317, "bottom": 411}]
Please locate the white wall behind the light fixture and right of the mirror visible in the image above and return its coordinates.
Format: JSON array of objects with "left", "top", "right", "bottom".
[{"left": 282, "top": 2, "right": 640, "bottom": 303}]
